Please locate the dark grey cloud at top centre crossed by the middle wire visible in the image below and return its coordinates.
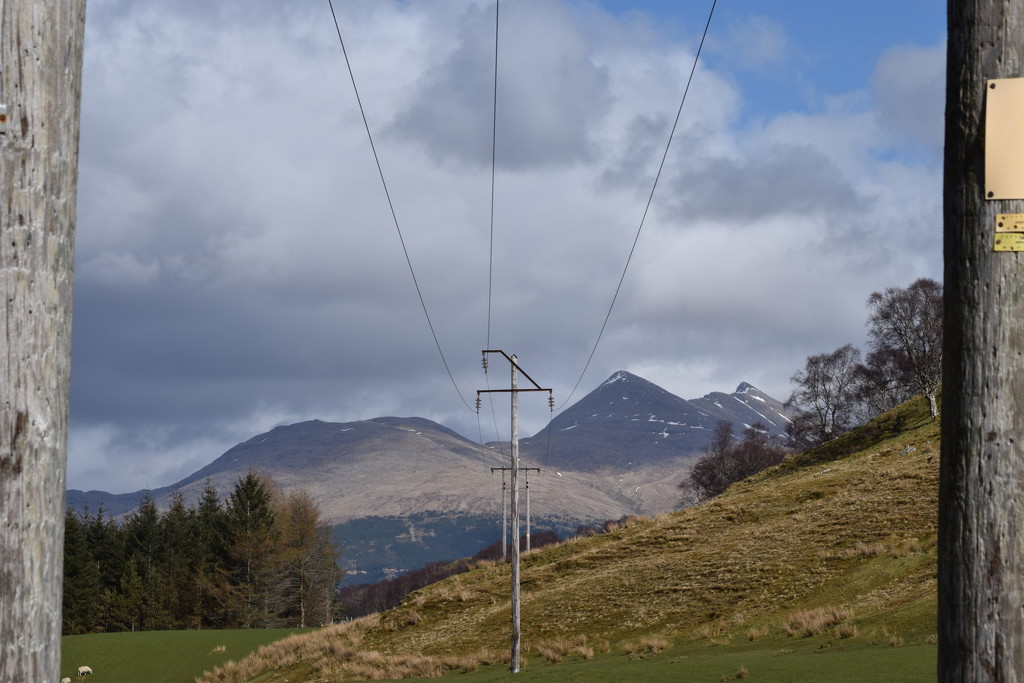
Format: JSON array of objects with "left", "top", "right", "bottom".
[{"left": 390, "top": 2, "right": 608, "bottom": 169}]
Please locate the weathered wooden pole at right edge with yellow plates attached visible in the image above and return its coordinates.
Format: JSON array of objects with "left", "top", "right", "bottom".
[{"left": 938, "top": 0, "right": 1024, "bottom": 682}]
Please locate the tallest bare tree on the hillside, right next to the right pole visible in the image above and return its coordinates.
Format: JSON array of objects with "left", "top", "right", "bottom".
[{"left": 867, "top": 278, "right": 942, "bottom": 418}]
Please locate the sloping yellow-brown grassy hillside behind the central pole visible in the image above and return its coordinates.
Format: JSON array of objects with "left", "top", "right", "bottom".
[{"left": 195, "top": 399, "right": 939, "bottom": 681}]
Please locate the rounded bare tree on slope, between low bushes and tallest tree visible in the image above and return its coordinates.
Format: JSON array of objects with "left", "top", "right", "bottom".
[{"left": 785, "top": 344, "right": 860, "bottom": 450}]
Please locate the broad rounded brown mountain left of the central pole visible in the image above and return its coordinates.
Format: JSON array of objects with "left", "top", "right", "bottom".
[{"left": 68, "top": 417, "right": 635, "bottom": 524}]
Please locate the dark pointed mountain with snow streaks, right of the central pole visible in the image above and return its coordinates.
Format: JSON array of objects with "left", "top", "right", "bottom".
[{"left": 520, "top": 371, "right": 788, "bottom": 471}]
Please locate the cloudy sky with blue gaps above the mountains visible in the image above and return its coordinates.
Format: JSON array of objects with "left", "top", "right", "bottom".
[{"left": 69, "top": 0, "right": 945, "bottom": 493}]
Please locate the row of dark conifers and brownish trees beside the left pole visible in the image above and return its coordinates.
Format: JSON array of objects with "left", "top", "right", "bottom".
[{"left": 63, "top": 472, "right": 342, "bottom": 634}]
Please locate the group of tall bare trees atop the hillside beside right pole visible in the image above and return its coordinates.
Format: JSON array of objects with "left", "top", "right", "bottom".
[{"left": 786, "top": 278, "right": 942, "bottom": 451}]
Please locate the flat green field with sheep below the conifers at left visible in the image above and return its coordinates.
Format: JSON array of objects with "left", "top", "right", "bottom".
[{"left": 60, "top": 629, "right": 312, "bottom": 683}]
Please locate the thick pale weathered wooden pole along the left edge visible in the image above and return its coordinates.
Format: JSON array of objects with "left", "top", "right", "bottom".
[{"left": 0, "top": 0, "right": 85, "bottom": 681}]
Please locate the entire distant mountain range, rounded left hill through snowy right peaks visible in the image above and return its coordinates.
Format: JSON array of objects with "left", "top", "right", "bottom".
[{"left": 67, "top": 372, "right": 784, "bottom": 581}]
